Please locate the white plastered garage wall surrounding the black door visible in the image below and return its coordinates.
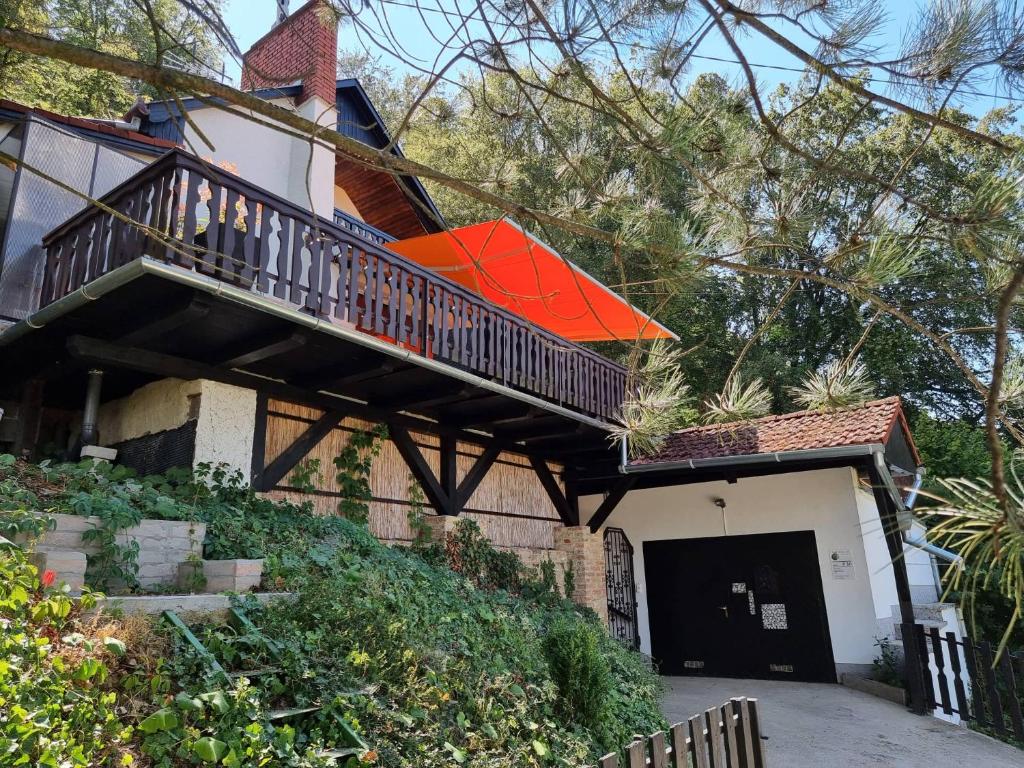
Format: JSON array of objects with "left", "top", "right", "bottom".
[{"left": 580, "top": 468, "right": 895, "bottom": 666}]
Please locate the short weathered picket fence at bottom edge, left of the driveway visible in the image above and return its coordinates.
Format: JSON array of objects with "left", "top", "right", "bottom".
[{"left": 599, "top": 698, "right": 767, "bottom": 768}]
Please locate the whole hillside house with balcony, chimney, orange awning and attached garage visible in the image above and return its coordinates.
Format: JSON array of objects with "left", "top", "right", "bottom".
[{"left": 0, "top": 0, "right": 958, "bottom": 716}]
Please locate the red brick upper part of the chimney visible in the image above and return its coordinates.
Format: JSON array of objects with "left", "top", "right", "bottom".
[{"left": 242, "top": 0, "right": 338, "bottom": 104}]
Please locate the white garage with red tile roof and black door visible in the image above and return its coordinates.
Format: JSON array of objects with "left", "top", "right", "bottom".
[{"left": 575, "top": 398, "right": 940, "bottom": 682}]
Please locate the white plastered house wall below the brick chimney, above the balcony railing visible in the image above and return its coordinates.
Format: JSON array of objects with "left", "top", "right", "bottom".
[{"left": 179, "top": 97, "right": 338, "bottom": 218}]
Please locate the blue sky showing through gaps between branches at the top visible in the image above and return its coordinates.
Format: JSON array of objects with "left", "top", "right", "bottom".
[{"left": 224, "top": 0, "right": 1008, "bottom": 114}]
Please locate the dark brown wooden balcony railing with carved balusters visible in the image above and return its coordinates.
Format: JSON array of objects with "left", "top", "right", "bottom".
[{"left": 41, "top": 150, "right": 626, "bottom": 420}]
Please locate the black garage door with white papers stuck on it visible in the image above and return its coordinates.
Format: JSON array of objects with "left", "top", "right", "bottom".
[{"left": 643, "top": 530, "right": 836, "bottom": 682}]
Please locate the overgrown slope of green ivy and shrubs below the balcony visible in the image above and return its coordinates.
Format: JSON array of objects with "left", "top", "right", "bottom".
[{"left": 0, "top": 462, "right": 663, "bottom": 768}]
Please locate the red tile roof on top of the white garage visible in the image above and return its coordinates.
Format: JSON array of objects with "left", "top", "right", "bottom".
[{"left": 636, "top": 397, "right": 920, "bottom": 464}]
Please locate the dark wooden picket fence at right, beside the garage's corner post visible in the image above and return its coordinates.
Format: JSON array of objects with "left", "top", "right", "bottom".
[{"left": 901, "top": 624, "right": 1024, "bottom": 741}]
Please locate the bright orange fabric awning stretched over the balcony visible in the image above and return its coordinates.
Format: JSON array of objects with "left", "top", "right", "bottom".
[{"left": 387, "top": 219, "right": 679, "bottom": 341}]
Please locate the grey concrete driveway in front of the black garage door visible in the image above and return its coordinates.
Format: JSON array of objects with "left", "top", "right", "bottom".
[{"left": 663, "top": 677, "right": 1024, "bottom": 768}]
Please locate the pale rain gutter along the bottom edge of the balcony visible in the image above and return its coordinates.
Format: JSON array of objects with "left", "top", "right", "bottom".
[{"left": 0, "top": 256, "right": 610, "bottom": 431}]
